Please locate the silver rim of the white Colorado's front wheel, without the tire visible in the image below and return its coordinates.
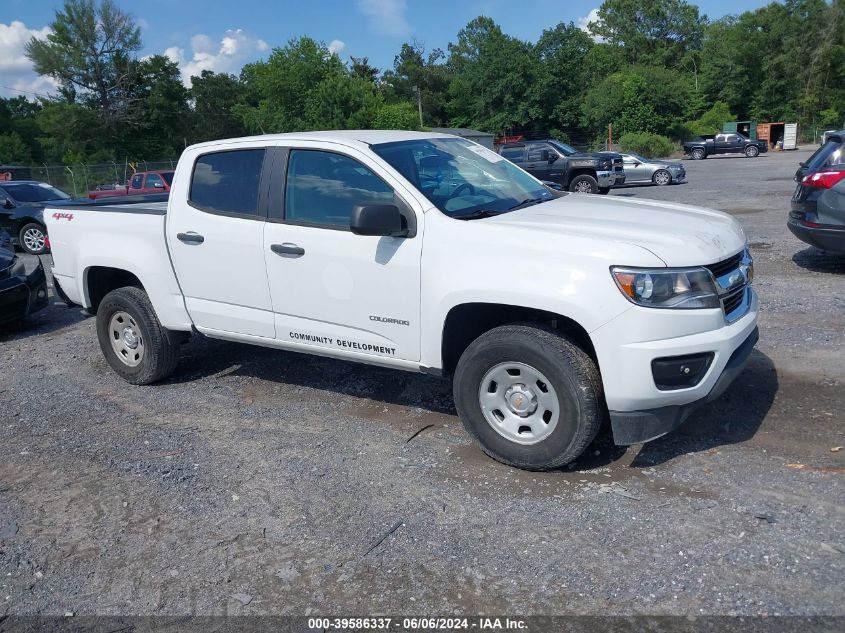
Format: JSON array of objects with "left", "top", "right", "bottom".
[{"left": 478, "top": 362, "right": 560, "bottom": 444}]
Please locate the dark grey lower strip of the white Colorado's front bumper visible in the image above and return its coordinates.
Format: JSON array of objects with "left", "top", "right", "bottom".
[{"left": 610, "top": 327, "right": 760, "bottom": 445}]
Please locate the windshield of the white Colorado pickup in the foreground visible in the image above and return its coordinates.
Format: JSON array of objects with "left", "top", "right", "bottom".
[{"left": 372, "top": 138, "right": 555, "bottom": 218}]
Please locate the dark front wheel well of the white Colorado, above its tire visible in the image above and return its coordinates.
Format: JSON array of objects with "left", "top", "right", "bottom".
[{"left": 440, "top": 302, "right": 598, "bottom": 376}]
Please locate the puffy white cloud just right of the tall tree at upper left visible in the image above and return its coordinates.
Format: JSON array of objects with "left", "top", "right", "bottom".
[{"left": 164, "top": 29, "right": 270, "bottom": 86}]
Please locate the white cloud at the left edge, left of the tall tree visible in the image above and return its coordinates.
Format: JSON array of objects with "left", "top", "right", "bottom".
[{"left": 0, "top": 20, "right": 58, "bottom": 99}]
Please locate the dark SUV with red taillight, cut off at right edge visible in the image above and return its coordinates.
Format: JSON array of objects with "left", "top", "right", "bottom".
[{"left": 787, "top": 130, "right": 845, "bottom": 253}]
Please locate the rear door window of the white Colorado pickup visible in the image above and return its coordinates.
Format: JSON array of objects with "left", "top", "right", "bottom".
[{"left": 188, "top": 149, "right": 264, "bottom": 217}]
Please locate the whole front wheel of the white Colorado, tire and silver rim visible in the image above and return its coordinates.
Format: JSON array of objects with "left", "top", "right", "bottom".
[{"left": 453, "top": 325, "right": 607, "bottom": 470}]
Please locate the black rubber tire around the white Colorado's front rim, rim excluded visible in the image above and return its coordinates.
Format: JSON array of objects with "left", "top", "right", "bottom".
[{"left": 453, "top": 324, "right": 607, "bottom": 470}]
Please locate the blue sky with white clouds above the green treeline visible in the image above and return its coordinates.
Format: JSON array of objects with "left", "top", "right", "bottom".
[{"left": 0, "top": 0, "right": 780, "bottom": 98}]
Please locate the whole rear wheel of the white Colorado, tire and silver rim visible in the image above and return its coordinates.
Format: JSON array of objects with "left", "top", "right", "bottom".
[{"left": 97, "top": 287, "right": 179, "bottom": 385}]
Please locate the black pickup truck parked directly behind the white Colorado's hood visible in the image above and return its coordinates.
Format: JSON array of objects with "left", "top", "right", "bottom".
[{"left": 499, "top": 140, "right": 625, "bottom": 193}]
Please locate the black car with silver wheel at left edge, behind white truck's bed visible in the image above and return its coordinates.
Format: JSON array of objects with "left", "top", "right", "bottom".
[{"left": 0, "top": 180, "right": 78, "bottom": 255}]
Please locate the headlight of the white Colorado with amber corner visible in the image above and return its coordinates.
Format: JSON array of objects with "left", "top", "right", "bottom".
[{"left": 610, "top": 266, "right": 722, "bottom": 310}]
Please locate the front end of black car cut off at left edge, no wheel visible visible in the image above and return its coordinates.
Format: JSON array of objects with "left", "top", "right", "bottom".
[{"left": 0, "top": 249, "right": 49, "bottom": 324}]
